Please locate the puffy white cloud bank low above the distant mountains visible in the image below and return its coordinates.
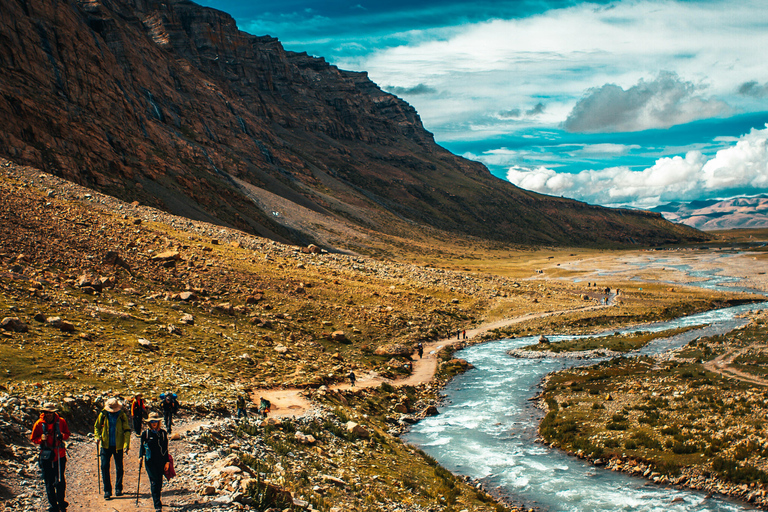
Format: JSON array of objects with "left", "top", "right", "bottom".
[{"left": 507, "top": 125, "right": 768, "bottom": 207}]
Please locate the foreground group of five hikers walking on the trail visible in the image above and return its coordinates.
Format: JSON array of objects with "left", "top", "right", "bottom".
[{"left": 30, "top": 393, "right": 179, "bottom": 512}]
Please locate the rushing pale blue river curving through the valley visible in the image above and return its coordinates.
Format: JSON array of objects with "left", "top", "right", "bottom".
[{"left": 405, "top": 266, "right": 768, "bottom": 512}]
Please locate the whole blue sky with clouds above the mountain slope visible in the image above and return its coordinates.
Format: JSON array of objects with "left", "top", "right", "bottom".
[{"left": 195, "top": 0, "right": 768, "bottom": 207}]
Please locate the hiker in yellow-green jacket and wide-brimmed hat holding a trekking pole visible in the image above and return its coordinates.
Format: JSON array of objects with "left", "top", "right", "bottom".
[{"left": 93, "top": 398, "right": 131, "bottom": 500}]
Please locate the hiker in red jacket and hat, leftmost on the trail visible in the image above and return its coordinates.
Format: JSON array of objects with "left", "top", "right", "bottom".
[{"left": 29, "top": 402, "right": 69, "bottom": 512}]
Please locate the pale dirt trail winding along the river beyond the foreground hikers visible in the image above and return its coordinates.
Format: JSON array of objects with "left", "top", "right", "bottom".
[{"left": 251, "top": 303, "right": 610, "bottom": 417}]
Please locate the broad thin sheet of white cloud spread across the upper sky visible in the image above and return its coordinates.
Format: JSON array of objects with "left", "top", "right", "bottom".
[{"left": 335, "top": 0, "right": 768, "bottom": 141}]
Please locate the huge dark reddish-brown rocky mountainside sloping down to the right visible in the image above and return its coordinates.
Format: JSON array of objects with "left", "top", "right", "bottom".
[{"left": 0, "top": 0, "right": 708, "bottom": 250}]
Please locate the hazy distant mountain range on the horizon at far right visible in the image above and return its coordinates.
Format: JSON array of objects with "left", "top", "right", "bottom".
[{"left": 652, "top": 195, "right": 768, "bottom": 231}]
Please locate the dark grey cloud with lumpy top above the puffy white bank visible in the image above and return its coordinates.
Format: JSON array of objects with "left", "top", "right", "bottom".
[{"left": 563, "top": 71, "right": 729, "bottom": 133}]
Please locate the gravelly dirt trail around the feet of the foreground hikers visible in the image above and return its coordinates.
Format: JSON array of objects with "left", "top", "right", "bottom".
[{"left": 60, "top": 420, "right": 211, "bottom": 512}]
